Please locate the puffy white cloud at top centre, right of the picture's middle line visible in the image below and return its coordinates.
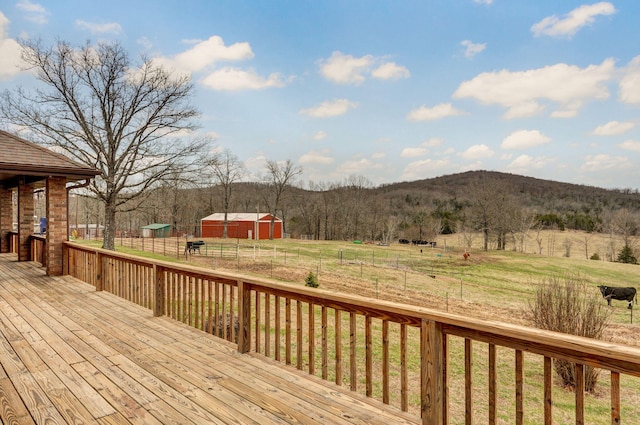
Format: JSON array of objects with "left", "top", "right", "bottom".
[{"left": 320, "top": 51, "right": 410, "bottom": 85}]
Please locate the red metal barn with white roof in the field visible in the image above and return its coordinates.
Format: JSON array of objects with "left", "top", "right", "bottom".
[{"left": 200, "top": 213, "right": 282, "bottom": 239}]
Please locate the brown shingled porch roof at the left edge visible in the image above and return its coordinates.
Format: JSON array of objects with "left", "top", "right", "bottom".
[{"left": 0, "top": 130, "right": 100, "bottom": 187}]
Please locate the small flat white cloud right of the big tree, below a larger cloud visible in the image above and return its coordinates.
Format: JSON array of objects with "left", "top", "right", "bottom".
[{"left": 200, "top": 67, "right": 285, "bottom": 91}]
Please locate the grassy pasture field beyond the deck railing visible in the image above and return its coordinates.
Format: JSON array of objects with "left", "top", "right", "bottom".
[{"left": 80, "top": 233, "right": 640, "bottom": 424}]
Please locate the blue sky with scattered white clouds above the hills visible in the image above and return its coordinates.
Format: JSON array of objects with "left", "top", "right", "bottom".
[{"left": 0, "top": 0, "right": 640, "bottom": 189}]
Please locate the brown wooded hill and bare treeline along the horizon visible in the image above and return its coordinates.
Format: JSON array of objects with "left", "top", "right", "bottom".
[{"left": 119, "top": 171, "right": 640, "bottom": 242}]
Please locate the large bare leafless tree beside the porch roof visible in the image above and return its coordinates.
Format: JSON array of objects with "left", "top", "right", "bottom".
[{"left": 0, "top": 40, "right": 204, "bottom": 250}]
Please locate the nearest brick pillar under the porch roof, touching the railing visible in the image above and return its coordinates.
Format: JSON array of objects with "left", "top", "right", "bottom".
[{"left": 46, "top": 177, "right": 69, "bottom": 276}]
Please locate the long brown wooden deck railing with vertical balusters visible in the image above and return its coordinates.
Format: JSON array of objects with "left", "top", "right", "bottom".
[{"left": 64, "top": 243, "right": 640, "bottom": 424}]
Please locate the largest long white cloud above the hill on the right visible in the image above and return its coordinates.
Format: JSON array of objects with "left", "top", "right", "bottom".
[{"left": 453, "top": 59, "right": 615, "bottom": 118}]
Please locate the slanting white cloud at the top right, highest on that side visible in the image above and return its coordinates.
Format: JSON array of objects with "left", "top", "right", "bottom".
[{"left": 531, "top": 1, "right": 616, "bottom": 37}]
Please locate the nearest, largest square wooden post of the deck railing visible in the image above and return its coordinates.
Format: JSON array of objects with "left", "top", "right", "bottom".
[{"left": 420, "top": 319, "right": 447, "bottom": 425}]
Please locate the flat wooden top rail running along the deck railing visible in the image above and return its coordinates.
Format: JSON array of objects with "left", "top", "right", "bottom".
[{"left": 65, "top": 242, "right": 640, "bottom": 377}]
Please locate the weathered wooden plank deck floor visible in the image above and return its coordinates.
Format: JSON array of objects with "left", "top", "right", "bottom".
[{"left": 0, "top": 254, "right": 418, "bottom": 425}]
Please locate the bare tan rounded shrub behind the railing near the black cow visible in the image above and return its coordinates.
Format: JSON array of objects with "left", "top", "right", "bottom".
[{"left": 527, "top": 276, "right": 611, "bottom": 392}]
